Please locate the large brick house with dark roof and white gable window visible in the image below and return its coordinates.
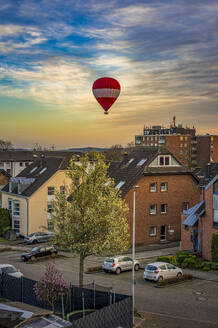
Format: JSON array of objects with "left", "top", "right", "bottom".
[{"left": 109, "top": 147, "right": 200, "bottom": 244}]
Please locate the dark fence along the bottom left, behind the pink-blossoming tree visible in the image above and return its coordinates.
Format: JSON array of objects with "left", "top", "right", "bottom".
[{"left": 0, "top": 274, "right": 132, "bottom": 328}]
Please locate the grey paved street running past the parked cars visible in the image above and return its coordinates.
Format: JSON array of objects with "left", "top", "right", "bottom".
[{"left": 0, "top": 247, "right": 218, "bottom": 327}]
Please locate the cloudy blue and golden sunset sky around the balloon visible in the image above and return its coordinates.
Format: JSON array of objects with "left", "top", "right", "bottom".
[{"left": 0, "top": 0, "right": 218, "bottom": 149}]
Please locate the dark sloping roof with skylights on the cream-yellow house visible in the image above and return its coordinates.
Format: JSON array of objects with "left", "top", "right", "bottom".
[{"left": 2, "top": 154, "right": 71, "bottom": 197}]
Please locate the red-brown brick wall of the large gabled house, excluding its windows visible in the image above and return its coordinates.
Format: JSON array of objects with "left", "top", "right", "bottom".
[{"left": 125, "top": 174, "right": 200, "bottom": 244}]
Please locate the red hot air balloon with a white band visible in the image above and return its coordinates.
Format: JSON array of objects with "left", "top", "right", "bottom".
[{"left": 92, "top": 77, "right": 120, "bottom": 114}]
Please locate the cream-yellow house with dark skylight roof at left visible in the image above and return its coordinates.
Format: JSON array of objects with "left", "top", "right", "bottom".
[{"left": 2, "top": 157, "right": 72, "bottom": 236}]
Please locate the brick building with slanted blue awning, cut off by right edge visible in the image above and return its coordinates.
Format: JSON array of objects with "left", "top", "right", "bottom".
[{"left": 181, "top": 163, "right": 218, "bottom": 260}]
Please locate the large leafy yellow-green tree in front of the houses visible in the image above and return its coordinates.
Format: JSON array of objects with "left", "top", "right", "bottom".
[{"left": 53, "top": 152, "right": 129, "bottom": 286}]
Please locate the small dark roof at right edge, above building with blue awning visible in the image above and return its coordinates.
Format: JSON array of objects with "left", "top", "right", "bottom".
[{"left": 193, "top": 163, "right": 218, "bottom": 187}]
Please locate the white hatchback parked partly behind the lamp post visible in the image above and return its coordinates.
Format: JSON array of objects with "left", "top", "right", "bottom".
[{"left": 102, "top": 255, "right": 139, "bottom": 274}]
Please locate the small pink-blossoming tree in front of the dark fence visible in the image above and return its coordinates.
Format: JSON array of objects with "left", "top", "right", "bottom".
[{"left": 34, "top": 263, "right": 69, "bottom": 312}]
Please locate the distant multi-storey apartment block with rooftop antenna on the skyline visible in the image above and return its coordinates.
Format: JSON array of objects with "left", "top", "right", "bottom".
[{"left": 135, "top": 117, "right": 218, "bottom": 167}]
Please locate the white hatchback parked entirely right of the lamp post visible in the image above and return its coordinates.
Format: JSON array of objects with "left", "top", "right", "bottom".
[{"left": 143, "top": 262, "right": 183, "bottom": 281}]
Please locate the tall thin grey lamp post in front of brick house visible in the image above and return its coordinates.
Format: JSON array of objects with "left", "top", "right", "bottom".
[{"left": 132, "top": 186, "right": 139, "bottom": 325}]
